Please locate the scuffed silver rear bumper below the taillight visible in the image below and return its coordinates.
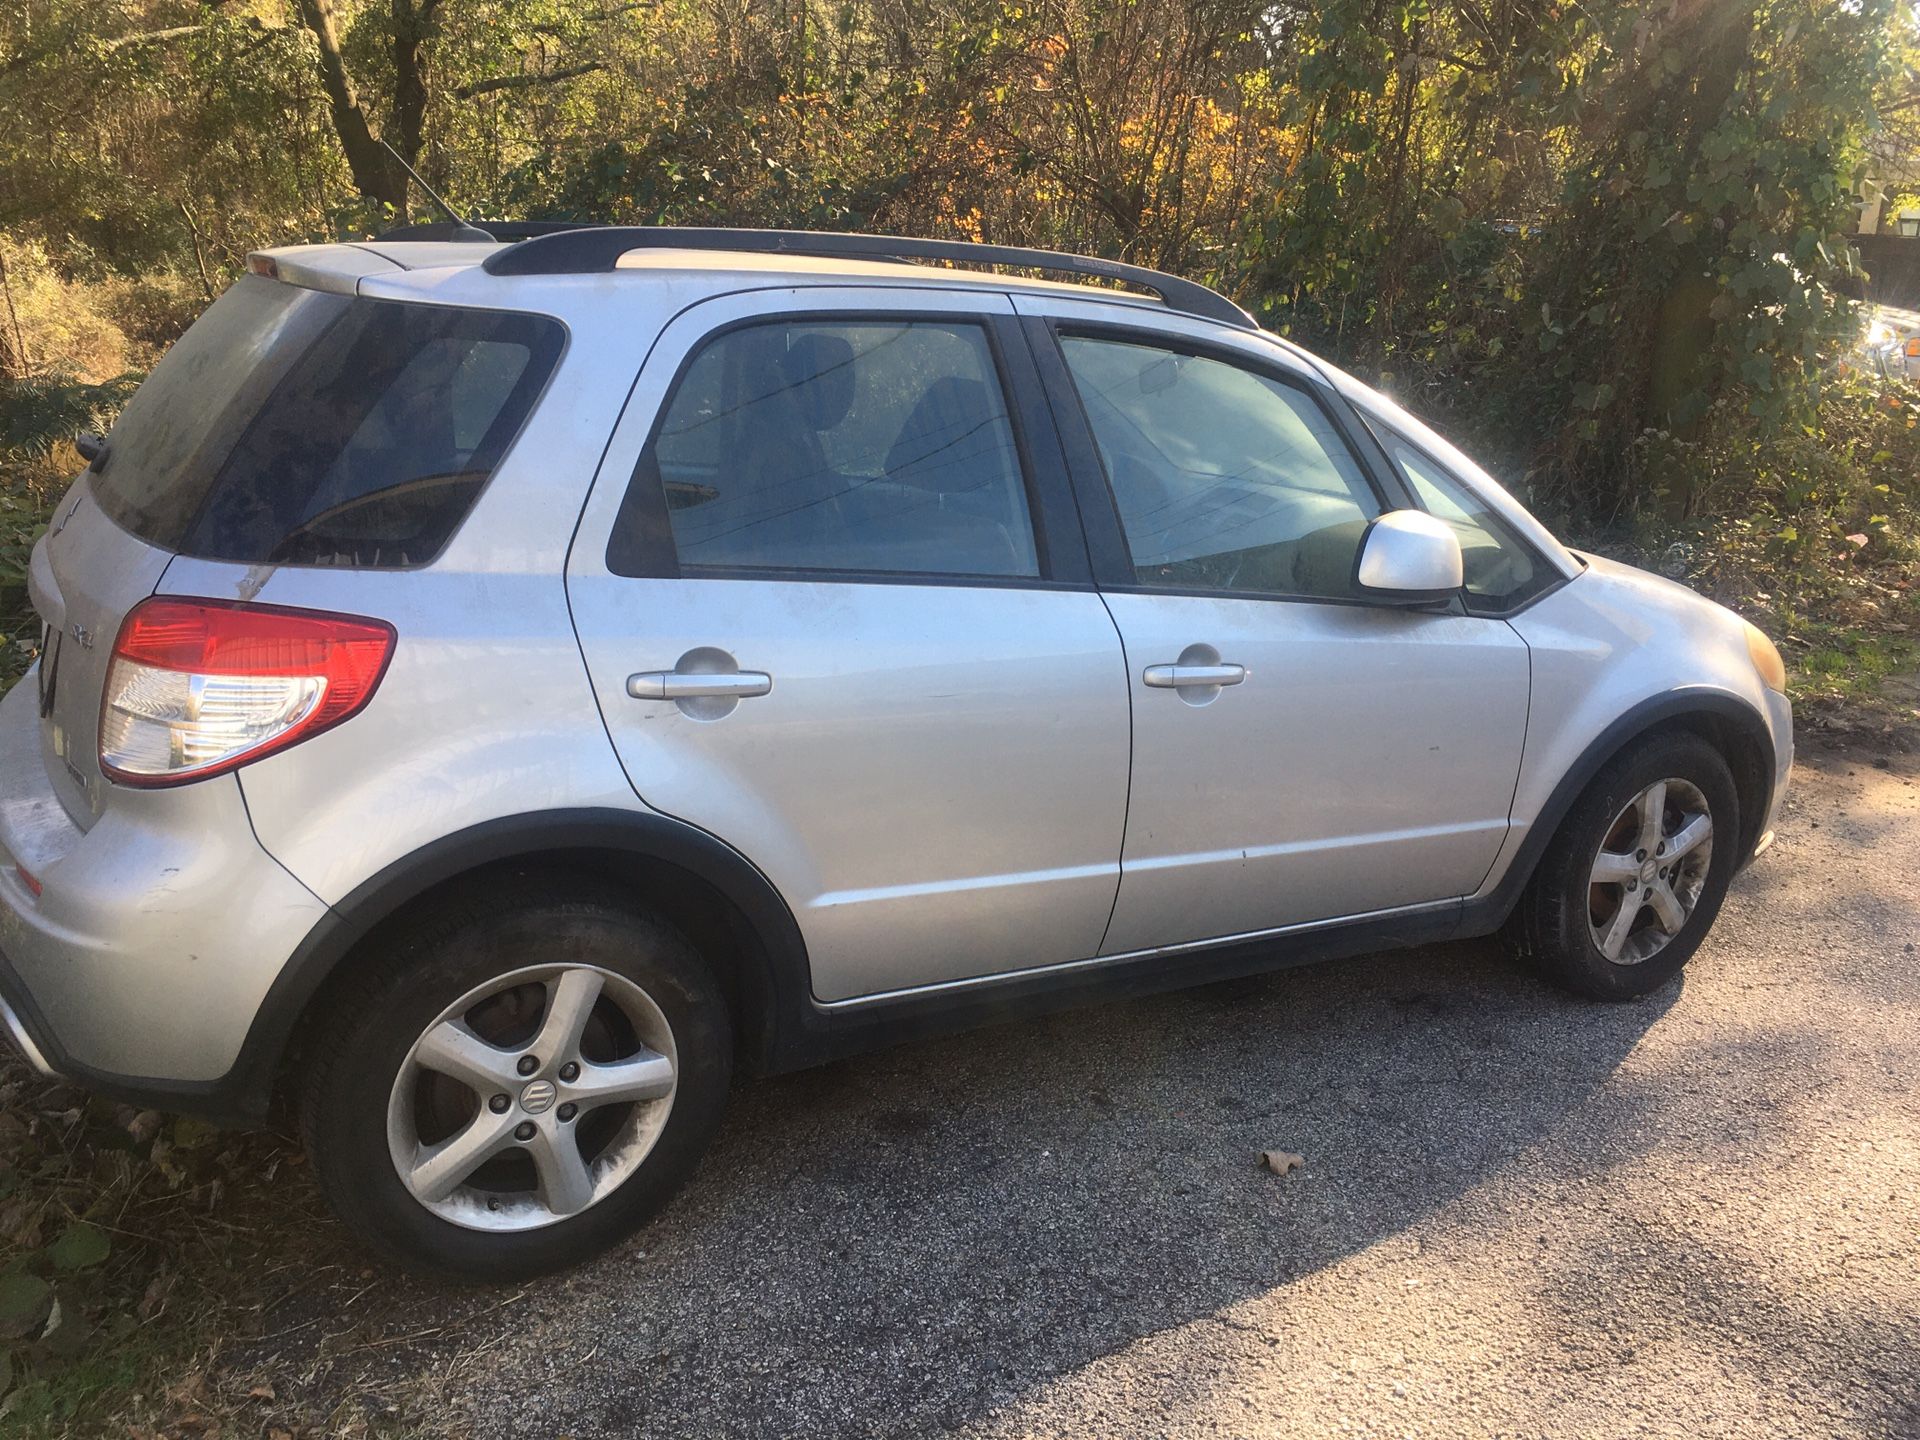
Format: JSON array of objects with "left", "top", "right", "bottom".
[{"left": 0, "top": 678, "right": 328, "bottom": 1112}]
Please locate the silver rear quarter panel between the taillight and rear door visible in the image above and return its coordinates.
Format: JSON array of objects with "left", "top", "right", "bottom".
[{"left": 159, "top": 271, "right": 680, "bottom": 904}]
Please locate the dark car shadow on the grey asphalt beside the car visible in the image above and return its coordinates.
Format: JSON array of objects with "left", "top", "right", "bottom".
[{"left": 474, "top": 941, "right": 1680, "bottom": 1436}]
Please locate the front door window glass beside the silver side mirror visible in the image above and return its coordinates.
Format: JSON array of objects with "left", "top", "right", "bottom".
[{"left": 1060, "top": 336, "right": 1380, "bottom": 599}]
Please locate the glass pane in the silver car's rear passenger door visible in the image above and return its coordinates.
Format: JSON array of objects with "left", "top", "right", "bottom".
[{"left": 629, "top": 321, "right": 1039, "bottom": 578}]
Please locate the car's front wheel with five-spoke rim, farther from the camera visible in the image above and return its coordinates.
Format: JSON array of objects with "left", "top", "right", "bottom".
[{"left": 1507, "top": 732, "right": 1740, "bottom": 1000}]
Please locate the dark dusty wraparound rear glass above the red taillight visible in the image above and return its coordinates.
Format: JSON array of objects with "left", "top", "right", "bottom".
[{"left": 92, "top": 275, "right": 566, "bottom": 568}]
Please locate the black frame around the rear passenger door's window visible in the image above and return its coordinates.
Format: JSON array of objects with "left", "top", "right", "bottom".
[{"left": 603, "top": 305, "right": 1094, "bottom": 591}]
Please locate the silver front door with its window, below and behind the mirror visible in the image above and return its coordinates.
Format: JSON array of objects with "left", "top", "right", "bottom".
[{"left": 1021, "top": 307, "right": 1528, "bottom": 954}]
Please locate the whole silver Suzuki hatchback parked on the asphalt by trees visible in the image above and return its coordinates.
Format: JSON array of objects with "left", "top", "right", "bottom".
[{"left": 0, "top": 227, "right": 1791, "bottom": 1279}]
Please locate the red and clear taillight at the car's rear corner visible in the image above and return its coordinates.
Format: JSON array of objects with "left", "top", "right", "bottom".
[{"left": 100, "top": 599, "right": 394, "bottom": 785}]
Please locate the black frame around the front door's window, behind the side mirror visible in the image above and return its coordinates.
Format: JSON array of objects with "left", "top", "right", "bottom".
[{"left": 1021, "top": 315, "right": 1467, "bottom": 614}]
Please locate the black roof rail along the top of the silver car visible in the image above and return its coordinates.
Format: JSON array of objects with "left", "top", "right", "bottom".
[{"left": 484, "top": 225, "right": 1258, "bottom": 330}]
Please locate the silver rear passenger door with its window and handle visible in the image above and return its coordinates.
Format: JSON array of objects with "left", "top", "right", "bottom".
[{"left": 568, "top": 288, "right": 1129, "bottom": 1000}]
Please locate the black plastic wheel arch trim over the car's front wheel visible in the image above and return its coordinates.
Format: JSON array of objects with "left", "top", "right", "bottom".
[{"left": 1461, "top": 687, "right": 1776, "bottom": 935}]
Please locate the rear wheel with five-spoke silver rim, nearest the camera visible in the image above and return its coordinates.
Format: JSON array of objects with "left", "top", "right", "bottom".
[{"left": 300, "top": 889, "right": 733, "bottom": 1281}]
